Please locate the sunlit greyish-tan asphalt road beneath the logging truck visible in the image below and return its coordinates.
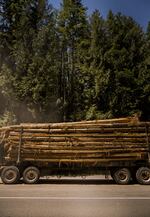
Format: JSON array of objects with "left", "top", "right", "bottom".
[{"left": 0, "top": 177, "right": 150, "bottom": 217}]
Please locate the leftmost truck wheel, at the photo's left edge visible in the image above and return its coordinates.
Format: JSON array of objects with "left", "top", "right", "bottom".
[{"left": 1, "top": 166, "right": 20, "bottom": 184}]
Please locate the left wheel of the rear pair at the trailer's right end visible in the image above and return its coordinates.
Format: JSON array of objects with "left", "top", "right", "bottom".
[{"left": 112, "top": 168, "right": 131, "bottom": 185}]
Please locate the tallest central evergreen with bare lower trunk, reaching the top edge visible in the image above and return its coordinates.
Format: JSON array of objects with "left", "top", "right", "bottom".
[{"left": 58, "top": 0, "right": 87, "bottom": 120}]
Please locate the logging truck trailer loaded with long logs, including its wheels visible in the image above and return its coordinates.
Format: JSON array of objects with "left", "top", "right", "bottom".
[{"left": 0, "top": 117, "right": 150, "bottom": 185}]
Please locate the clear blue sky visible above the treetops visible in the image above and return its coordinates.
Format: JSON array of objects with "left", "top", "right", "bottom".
[{"left": 49, "top": 0, "right": 150, "bottom": 29}]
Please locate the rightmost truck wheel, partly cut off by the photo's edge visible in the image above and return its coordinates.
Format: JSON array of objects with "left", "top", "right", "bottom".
[{"left": 136, "top": 167, "right": 150, "bottom": 185}]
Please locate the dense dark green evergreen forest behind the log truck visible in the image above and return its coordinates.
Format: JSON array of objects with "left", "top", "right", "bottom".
[{"left": 0, "top": 0, "right": 150, "bottom": 126}]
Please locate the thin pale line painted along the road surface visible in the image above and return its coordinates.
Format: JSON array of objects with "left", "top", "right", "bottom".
[{"left": 0, "top": 197, "right": 150, "bottom": 200}]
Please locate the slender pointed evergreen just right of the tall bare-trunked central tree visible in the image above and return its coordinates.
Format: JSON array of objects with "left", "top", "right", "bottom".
[{"left": 77, "top": 10, "right": 108, "bottom": 119}]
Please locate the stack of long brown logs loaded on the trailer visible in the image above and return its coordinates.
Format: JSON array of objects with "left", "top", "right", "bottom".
[{"left": 0, "top": 118, "right": 150, "bottom": 162}]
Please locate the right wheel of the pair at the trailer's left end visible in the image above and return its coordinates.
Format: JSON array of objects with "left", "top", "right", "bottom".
[{"left": 23, "top": 167, "right": 40, "bottom": 184}]
